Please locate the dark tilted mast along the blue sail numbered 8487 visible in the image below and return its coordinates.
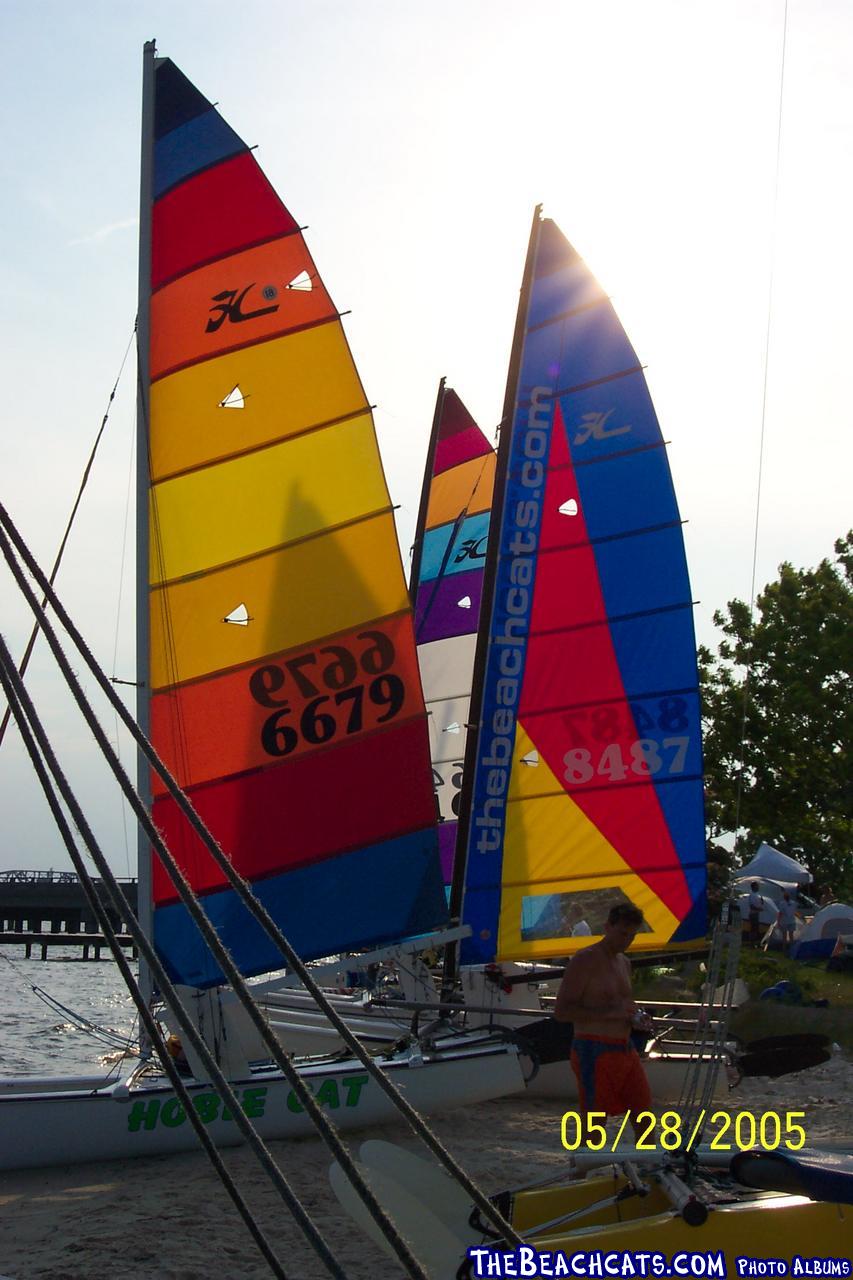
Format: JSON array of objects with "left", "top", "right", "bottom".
[{"left": 442, "top": 205, "right": 542, "bottom": 991}]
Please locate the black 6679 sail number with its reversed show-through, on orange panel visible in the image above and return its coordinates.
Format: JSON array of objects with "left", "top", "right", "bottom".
[{"left": 248, "top": 631, "right": 406, "bottom": 755}]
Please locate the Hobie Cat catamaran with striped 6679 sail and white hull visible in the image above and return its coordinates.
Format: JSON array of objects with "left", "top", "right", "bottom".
[{"left": 0, "top": 44, "right": 523, "bottom": 1169}]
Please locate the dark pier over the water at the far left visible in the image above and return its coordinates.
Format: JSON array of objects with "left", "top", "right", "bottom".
[{"left": 0, "top": 870, "right": 137, "bottom": 960}]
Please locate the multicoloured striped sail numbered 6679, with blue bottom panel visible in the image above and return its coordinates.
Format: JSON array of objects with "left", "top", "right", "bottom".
[{"left": 143, "top": 59, "right": 446, "bottom": 986}]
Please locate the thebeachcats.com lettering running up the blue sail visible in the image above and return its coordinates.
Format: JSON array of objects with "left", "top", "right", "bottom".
[{"left": 474, "top": 387, "right": 553, "bottom": 854}]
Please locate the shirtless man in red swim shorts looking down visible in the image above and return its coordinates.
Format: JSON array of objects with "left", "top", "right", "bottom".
[{"left": 555, "top": 902, "right": 652, "bottom": 1133}]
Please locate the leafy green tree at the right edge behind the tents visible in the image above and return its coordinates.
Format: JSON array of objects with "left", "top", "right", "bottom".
[{"left": 699, "top": 532, "right": 853, "bottom": 900}]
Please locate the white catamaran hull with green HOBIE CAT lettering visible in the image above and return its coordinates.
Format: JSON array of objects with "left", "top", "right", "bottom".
[{"left": 0, "top": 1044, "right": 524, "bottom": 1170}]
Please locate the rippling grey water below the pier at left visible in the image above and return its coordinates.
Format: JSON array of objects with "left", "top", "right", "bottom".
[{"left": 0, "top": 946, "right": 136, "bottom": 1075}]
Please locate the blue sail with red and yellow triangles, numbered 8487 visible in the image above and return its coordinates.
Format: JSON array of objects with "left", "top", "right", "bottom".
[{"left": 462, "top": 216, "right": 706, "bottom": 963}]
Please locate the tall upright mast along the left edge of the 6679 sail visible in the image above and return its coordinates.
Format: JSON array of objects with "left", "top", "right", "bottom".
[{"left": 136, "top": 40, "right": 156, "bottom": 1001}]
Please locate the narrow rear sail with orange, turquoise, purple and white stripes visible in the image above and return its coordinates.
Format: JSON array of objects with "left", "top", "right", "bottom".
[{"left": 411, "top": 380, "right": 494, "bottom": 884}]
